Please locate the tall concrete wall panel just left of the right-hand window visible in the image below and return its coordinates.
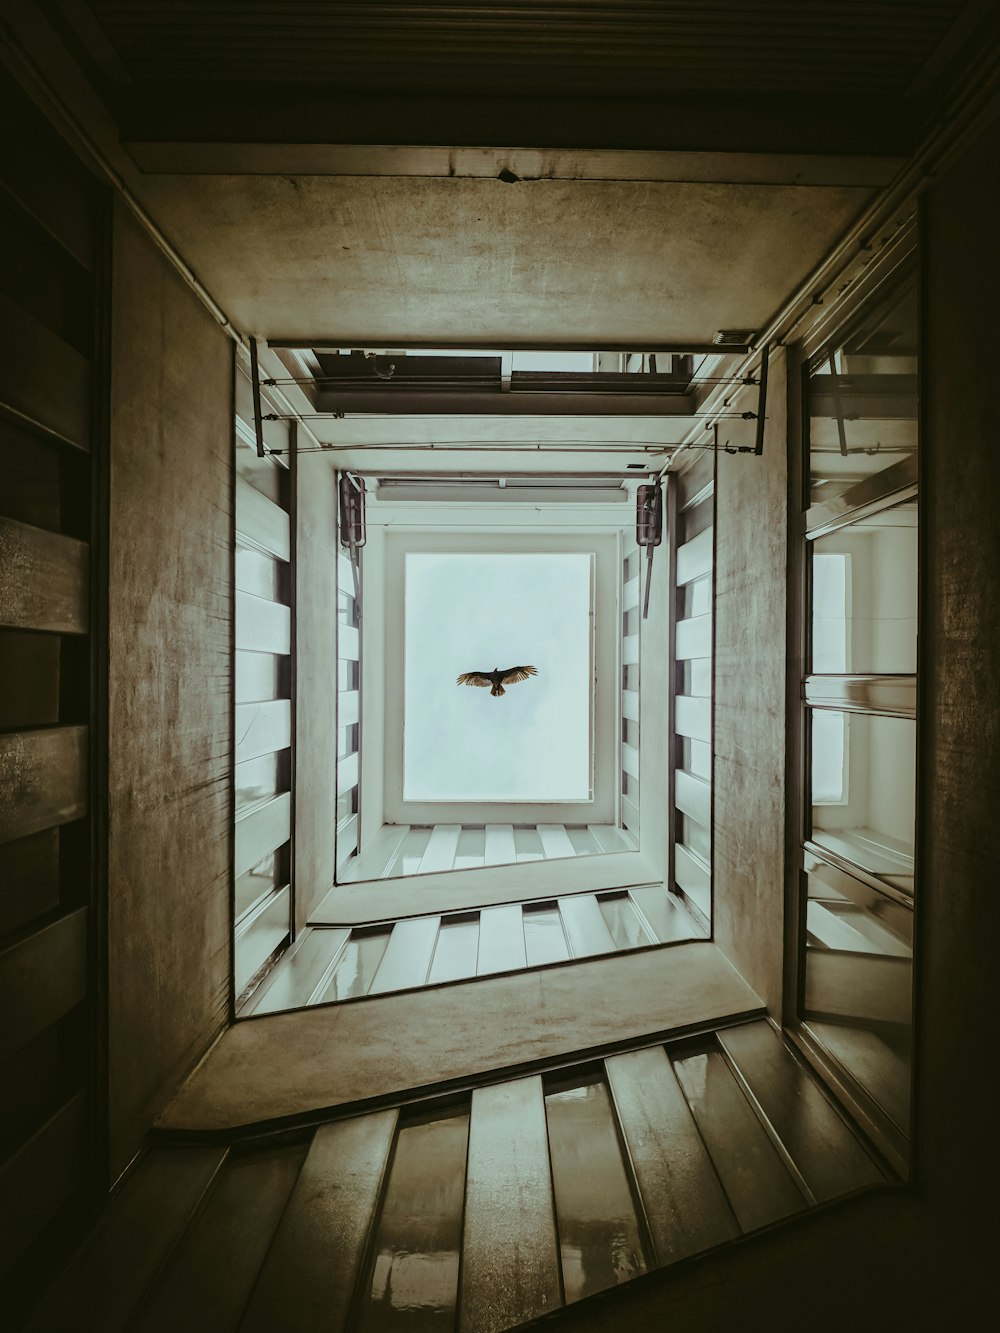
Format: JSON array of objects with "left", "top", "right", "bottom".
[{"left": 713, "top": 351, "right": 787, "bottom": 1017}]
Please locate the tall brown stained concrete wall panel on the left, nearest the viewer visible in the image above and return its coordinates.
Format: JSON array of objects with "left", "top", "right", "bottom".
[{"left": 108, "top": 204, "right": 233, "bottom": 1178}]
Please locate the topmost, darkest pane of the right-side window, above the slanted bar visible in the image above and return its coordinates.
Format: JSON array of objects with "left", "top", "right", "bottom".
[{"left": 808, "top": 280, "right": 917, "bottom": 504}]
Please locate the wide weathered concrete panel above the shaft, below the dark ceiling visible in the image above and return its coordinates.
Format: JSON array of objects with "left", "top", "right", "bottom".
[{"left": 135, "top": 176, "right": 872, "bottom": 347}]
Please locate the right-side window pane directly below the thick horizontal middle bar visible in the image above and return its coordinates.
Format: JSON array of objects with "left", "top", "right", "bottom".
[{"left": 809, "top": 709, "right": 916, "bottom": 892}]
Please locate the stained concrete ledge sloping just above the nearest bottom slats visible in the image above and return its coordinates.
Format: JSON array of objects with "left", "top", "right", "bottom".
[{"left": 157, "top": 944, "right": 761, "bottom": 1130}]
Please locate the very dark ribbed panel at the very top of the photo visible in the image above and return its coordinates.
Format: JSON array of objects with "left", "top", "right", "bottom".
[{"left": 68, "top": 0, "right": 968, "bottom": 97}]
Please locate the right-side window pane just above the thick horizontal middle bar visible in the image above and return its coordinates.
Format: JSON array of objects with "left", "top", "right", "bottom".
[{"left": 812, "top": 501, "right": 917, "bottom": 674}]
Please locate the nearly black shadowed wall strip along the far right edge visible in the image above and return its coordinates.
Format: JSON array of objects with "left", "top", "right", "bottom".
[{"left": 916, "top": 109, "right": 1000, "bottom": 1265}]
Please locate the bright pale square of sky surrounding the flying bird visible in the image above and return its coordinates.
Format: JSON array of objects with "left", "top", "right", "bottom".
[{"left": 403, "top": 552, "right": 593, "bottom": 801}]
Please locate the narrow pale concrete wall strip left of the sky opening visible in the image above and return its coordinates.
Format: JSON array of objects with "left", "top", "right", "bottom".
[{"left": 293, "top": 453, "right": 337, "bottom": 926}]
